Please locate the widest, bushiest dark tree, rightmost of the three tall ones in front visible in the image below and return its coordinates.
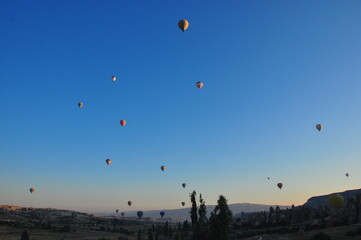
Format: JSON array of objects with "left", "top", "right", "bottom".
[{"left": 209, "top": 195, "right": 232, "bottom": 240}]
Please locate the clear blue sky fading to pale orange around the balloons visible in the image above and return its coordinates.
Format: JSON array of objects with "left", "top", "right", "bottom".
[{"left": 0, "top": 0, "right": 361, "bottom": 214}]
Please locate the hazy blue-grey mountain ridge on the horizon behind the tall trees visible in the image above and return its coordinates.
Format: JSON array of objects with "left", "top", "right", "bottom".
[{"left": 94, "top": 203, "right": 289, "bottom": 220}]
